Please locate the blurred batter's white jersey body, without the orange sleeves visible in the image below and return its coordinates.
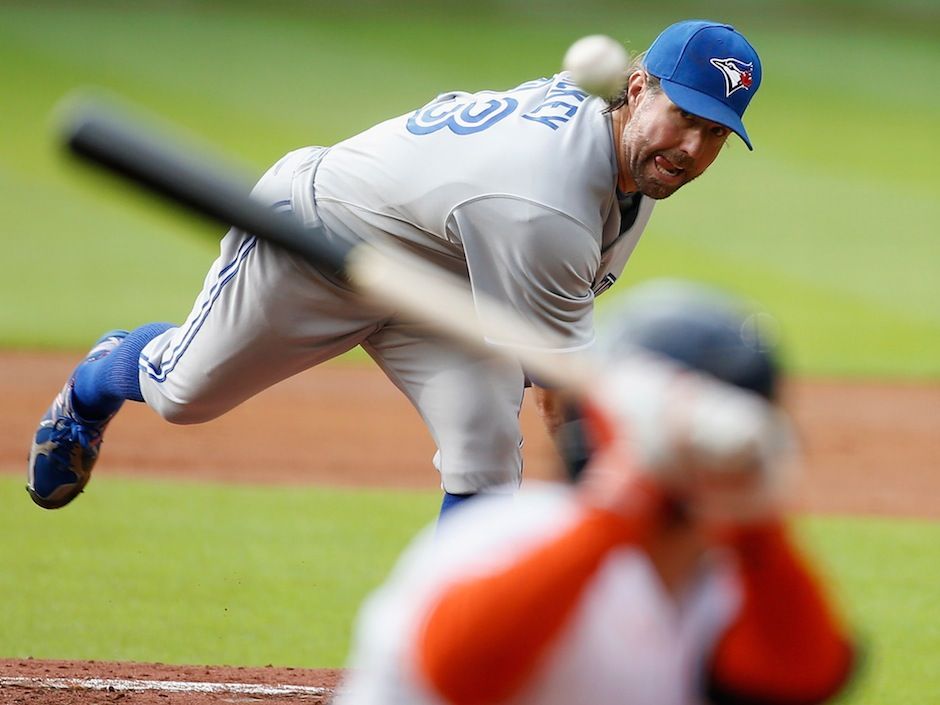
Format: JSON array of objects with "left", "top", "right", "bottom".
[{"left": 336, "top": 484, "right": 740, "bottom": 705}]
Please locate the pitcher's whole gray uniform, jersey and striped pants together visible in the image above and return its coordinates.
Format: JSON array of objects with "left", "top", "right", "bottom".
[{"left": 140, "top": 74, "right": 653, "bottom": 494}]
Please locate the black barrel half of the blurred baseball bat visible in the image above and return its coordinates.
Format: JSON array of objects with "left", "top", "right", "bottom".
[{"left": 63, "top": 105, "right": 354, "bottom": 276}]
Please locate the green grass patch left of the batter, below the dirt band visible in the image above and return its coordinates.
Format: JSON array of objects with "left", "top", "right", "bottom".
[{"left": 0, "top": 475, "right": 437, "bottom": 667}]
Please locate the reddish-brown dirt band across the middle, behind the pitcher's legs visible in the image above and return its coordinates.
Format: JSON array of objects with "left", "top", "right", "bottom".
[{"left": 0, "top": 353, "right": 940, "bottom": 517}]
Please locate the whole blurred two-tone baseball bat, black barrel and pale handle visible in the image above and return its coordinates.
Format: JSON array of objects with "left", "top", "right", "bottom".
[{"left": 60, "top": 93, "right": 594, "bottom": 394}]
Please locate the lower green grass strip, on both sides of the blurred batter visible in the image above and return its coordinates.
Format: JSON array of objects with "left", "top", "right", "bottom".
[{"left": 0, "top": 475, "right": 940, "bottom": 705}]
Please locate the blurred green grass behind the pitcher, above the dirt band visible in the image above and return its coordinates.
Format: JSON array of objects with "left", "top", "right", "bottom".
[{"left": 0, "top": 0, "right": 940, "bottom": 378}]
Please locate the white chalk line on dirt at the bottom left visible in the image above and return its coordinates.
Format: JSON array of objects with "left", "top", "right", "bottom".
[{"left": 0, "top": 676, "right": 332, "bottom": 696}]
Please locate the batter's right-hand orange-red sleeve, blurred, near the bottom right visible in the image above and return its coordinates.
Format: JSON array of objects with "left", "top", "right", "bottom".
[{"left": 709, "top": 523, "right": 853, "bottom": 705}]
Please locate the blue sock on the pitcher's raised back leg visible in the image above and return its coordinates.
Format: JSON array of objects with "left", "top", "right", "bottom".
[{"left": 72, "top": 323, "right": 173, "bottom": 420}]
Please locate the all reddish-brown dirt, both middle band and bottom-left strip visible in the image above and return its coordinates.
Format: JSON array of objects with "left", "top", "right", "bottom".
[{"left": 0, "top": 353, "right": 940, "bottom": 705}]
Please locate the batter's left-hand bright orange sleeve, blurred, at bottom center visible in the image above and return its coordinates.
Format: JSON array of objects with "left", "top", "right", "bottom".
[{"left": 416, "top": 510, "right": 650, "bottom": 705}]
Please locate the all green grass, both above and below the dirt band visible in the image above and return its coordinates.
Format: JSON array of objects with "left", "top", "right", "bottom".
[{"left": 0, "top": 0, "right": 940, "bottom": 705}]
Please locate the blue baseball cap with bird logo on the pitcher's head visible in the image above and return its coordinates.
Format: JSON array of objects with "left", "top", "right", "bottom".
[{"left": 645, "top": 20, "right": 761, "bottom": 150}]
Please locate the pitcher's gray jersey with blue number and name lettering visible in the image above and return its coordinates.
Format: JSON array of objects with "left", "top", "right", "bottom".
[{"left": 311, "top": 73, "right": 653, "bottom": 352}]
